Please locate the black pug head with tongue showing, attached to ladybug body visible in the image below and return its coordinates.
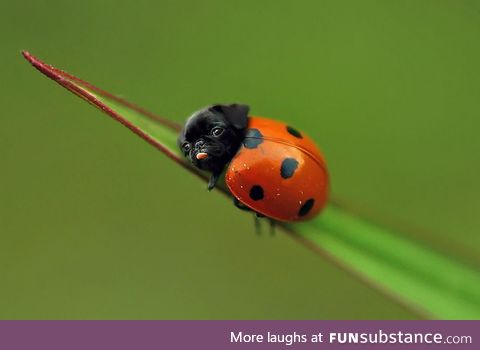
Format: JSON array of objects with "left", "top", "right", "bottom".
[{"left": 178, "top": 104, "right": 249, "bottom": 174}]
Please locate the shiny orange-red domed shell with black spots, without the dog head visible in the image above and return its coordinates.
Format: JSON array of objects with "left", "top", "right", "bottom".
[{"left": 225, "top": 117, "right": 328, "bottom": 221}]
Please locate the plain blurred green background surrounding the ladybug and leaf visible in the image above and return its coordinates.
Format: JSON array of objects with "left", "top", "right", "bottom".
[{"left": 0, "top": 0, "right": 480, "bottom": 319}]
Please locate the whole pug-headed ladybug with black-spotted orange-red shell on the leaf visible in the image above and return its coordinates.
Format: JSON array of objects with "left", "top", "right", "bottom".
[{"left": 178, "top": 104, "right": 328, "bottom": 222}]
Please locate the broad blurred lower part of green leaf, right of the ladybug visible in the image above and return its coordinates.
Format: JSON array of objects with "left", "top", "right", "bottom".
[{"left": 292, "top": 205, "right": 480, "bottom": 319}]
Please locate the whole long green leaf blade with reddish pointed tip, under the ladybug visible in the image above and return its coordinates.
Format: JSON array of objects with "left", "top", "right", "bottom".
[{"left": 23, "top": 52, "right": 480, "bottom": 319}]
